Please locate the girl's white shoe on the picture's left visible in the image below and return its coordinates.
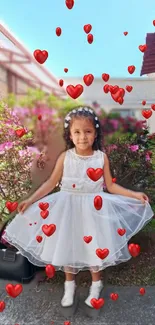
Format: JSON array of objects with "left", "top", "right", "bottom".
[{"left": 61, "top": 281, "right": 76, "bottom": 307}]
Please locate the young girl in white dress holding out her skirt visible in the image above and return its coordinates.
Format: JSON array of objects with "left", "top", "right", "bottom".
[{"left": 3, "top": 107, "right": 154, "bottom": 308}]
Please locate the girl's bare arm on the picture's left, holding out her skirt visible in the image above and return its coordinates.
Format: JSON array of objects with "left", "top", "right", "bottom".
[{"left": 28, "top": 152, "right": 66, "bottom": 203}]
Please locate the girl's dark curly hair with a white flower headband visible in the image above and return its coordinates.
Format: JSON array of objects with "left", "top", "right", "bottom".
[{"left": 63, "top": 106, "right": 103, "bottom": 151}]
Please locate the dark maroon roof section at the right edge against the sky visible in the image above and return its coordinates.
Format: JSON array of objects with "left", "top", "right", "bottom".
[{"left": 140, "top": 33, "right": 155, "bottom": 76}]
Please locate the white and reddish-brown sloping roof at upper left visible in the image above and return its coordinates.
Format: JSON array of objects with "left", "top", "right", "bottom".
[{"left": 0, "top": 21, "right": 66, "bottom": 97}]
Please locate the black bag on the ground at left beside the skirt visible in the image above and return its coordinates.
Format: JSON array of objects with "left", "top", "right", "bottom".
[{"left": 0, "top": 220, "right": 38, "bottom": 283}]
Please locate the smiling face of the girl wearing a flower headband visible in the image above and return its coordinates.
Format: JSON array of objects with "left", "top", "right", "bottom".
[{"left": 70, "top": 118, "right": 97, "bottom": 151}]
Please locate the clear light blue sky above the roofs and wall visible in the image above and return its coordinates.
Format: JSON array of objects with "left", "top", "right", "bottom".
[{"left": 0, "top": 0, "right": 155, "bottom": 78}]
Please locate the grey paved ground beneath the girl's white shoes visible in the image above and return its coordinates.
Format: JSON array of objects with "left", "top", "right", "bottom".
[{"left": 0, "top": 272, "right": 155, "bottom": 325}]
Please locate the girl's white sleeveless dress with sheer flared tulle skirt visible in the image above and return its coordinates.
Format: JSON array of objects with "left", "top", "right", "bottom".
[{"left": 3, "top": 148, "right": 154, "bottom": 274}]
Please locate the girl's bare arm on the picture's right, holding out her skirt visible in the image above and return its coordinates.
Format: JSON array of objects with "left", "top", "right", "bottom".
[{"left": 103, "top": 154, "right": 136, "bottom": 198}]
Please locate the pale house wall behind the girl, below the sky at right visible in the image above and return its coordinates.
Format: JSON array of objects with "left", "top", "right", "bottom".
[{"left": 63, "top": 77, "right": 155, "bottom": 133}]
